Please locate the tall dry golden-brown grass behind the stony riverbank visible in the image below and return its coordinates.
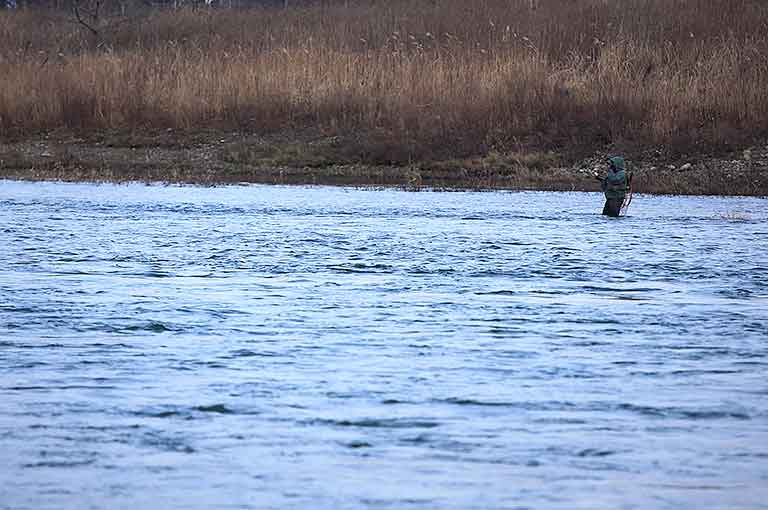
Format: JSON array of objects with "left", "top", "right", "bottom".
[{"left": 0, "top": 0, "right": 768, "bottom": 164}]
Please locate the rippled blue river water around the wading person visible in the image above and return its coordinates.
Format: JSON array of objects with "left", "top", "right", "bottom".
[{"left": 0, "top": 181, "right": 768, "bottom": 509}]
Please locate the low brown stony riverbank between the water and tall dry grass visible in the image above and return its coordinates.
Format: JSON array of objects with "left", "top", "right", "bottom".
[{"left": 0, "top": 130, "right": 768, "bottom": 196}]
